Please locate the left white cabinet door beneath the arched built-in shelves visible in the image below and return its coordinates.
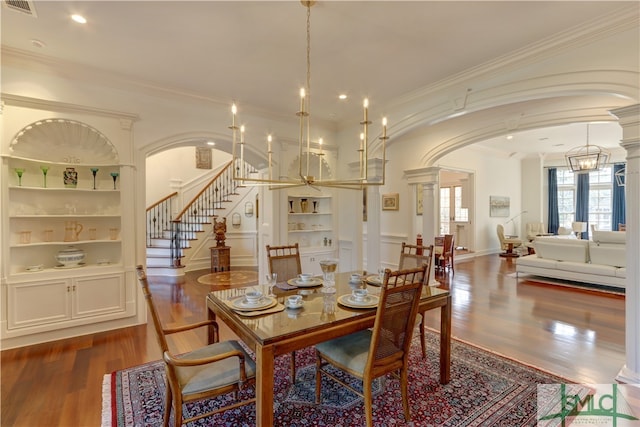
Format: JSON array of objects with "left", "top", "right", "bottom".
[{"left": 8, "top": 279, "right": 72, "bottom": 329}]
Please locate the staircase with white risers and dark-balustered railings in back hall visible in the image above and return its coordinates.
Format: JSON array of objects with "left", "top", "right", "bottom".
[{"left": 146, "top": 162, "right": 255, "bottom": 276}]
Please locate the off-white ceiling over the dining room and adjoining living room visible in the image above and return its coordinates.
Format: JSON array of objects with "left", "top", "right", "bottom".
[{"left": 1, "top": 0, "right": 629, "bottom": 153}]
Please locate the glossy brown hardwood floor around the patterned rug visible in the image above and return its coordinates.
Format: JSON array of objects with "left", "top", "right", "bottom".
[{"left": 0, "top": 255, "right": 625, "bottom": 426}]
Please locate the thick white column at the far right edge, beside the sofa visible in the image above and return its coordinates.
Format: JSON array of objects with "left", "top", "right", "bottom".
[{"left": 611, "top": 104, "right": 640, "bottom": 384}]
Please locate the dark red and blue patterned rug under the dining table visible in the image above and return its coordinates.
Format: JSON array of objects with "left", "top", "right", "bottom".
[{"left": 102, "top": 332, "right": 577, "bottom": 427}]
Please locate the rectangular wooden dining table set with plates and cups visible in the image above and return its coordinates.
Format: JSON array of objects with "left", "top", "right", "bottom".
[{"left": 206, "top": 272, "right": 451, "bottom": 427}]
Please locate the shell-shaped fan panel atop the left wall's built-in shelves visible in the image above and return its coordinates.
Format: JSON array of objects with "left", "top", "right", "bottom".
[{"left": 9, "top": 119, "right": 118, "bottom": 164}]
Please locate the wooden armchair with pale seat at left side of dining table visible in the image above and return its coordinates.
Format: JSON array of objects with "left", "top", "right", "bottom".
[{"left": 137, "top": 265, "right": 256, "bottom": 427}]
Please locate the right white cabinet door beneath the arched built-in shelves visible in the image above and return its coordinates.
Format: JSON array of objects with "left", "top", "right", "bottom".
[{"left": 72, "top": 274, "right": 125, "bottom": 318}]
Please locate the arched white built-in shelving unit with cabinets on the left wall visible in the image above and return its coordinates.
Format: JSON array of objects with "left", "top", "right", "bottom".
[{"left": 1, "top": 106, "right": 136, "bottom": 347}]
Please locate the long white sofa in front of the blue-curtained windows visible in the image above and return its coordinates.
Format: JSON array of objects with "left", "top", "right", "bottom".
[{"left": 516, "top": 230, "right": 627, "bottom": 288}]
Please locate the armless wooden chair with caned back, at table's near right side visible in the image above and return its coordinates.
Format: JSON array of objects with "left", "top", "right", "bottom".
[{"left": 316, "top": 265, "right": 427, "bottom": 427}]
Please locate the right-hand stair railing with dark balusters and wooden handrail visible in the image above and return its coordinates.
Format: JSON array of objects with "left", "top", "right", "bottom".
[{"left": 170, "top": 161, "right": 256, "bottom": 267}]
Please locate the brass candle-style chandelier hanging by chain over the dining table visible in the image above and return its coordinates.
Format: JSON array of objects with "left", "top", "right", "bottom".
[{"left": 229, "top": 0, "right": 389, "bottom": 190}]
